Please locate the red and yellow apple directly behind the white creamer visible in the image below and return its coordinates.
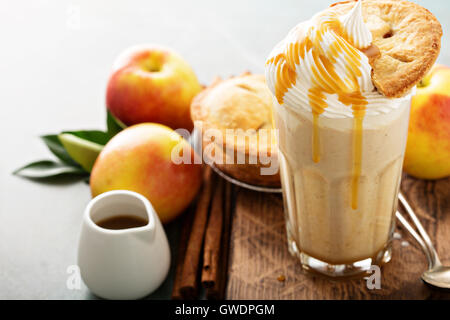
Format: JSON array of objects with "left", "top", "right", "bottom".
[{"left": 90, "top": 123, "right": 202, "bottom": 223}]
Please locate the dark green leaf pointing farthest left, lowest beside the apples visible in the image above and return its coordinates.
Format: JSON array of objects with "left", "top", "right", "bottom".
[{"left": 13, "top": 160, "right": 88, "bottom": 179}]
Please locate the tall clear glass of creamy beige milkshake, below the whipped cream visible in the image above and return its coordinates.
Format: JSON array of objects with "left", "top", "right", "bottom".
[{"left": 274, "top": 97, "right": 411, "bottom": 277}]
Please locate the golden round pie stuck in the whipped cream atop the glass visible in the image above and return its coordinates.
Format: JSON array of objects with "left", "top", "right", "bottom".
[{"left": 327, "top": 0, "right": 442, "bottom": 98}]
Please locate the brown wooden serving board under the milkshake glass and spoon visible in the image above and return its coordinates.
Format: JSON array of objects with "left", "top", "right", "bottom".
[{"left": 226, "top": 176, "right": 450, "bottom": 300}]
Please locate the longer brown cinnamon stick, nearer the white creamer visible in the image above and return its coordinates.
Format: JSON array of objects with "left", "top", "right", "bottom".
[{"left": 179, "top": 166, "right": 213, "bottom": 299}]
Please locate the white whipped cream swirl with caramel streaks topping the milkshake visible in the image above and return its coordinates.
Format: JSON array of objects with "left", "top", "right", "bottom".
[{"left": 265, "top": 1, "right": 409, "bottom": 118}]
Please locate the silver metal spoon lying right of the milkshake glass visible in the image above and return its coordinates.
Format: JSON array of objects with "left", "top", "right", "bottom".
[{"left": 396, "top": 193, "right": 450, "bottom": 289}]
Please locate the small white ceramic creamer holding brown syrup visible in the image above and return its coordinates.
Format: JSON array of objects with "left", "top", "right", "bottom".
[{"left": 78, "top": 190, "right": 170, "bottom": 299}]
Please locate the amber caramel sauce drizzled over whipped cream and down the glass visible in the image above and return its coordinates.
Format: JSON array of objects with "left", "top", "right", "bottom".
[{"left": 266, "top": 14, "right": 372, "bottom": 210}]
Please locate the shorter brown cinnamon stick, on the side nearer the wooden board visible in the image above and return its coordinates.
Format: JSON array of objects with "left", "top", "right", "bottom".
[{"left": 202, "top": 178, "right": 223, "bottom": 288}]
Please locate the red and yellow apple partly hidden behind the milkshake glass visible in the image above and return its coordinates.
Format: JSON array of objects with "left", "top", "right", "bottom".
[{"left": 404, "top": 65, "right": 450, "bottom": 179}]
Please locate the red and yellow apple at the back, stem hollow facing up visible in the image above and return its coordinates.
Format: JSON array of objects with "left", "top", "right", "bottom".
[{"left": 106, "top": 45, "right": 202, "bottom": 130}]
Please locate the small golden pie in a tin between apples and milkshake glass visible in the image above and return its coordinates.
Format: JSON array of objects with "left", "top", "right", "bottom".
[{"left": 191, "top": 73, "right": 281, "bottom": 187}]
